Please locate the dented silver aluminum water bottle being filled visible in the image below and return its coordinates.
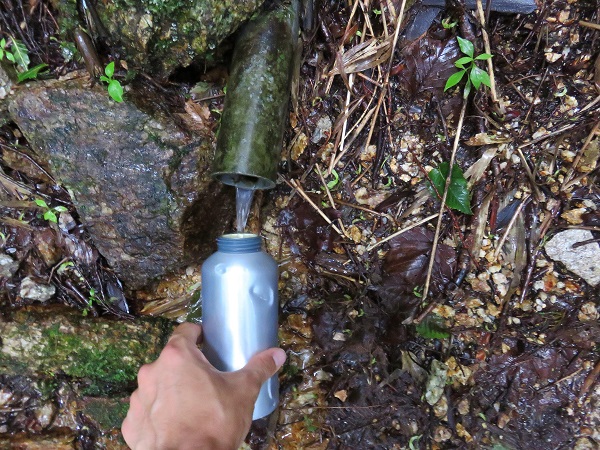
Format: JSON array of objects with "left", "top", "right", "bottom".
[{"left": 202, "top": 233, "right": 279, "bottom": 420}]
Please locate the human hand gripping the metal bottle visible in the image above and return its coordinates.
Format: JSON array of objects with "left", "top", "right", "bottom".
[{"left": 121, "top": 323, "right": 285, "bottom": 450}]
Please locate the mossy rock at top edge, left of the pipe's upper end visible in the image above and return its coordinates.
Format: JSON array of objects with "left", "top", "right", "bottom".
[{"left": 54, "top": 0, "right": 264, "bottom": 76}]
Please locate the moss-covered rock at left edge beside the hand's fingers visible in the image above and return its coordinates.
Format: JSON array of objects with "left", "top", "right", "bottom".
[{"left": 0, "top": 305, "right": 172, "bottom": 395}]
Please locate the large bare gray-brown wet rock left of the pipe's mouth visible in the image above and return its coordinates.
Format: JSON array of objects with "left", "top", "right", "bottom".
[{"left": 9, "top": 74, "right": 234, "bottom": 290}]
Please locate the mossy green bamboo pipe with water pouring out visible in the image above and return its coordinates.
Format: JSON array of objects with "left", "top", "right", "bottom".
[{"left": 212, "top": 0, "right": 299, "bottom": 189}]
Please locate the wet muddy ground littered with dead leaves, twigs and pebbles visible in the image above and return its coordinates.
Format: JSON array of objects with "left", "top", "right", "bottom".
[{"left": 0, "top": 0, "right": 600, "bottom": 450}]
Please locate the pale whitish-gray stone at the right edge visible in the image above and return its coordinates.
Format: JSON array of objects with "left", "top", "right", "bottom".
[{"left": 545, "top": 230, "right": 600, "bottom": 286}]
